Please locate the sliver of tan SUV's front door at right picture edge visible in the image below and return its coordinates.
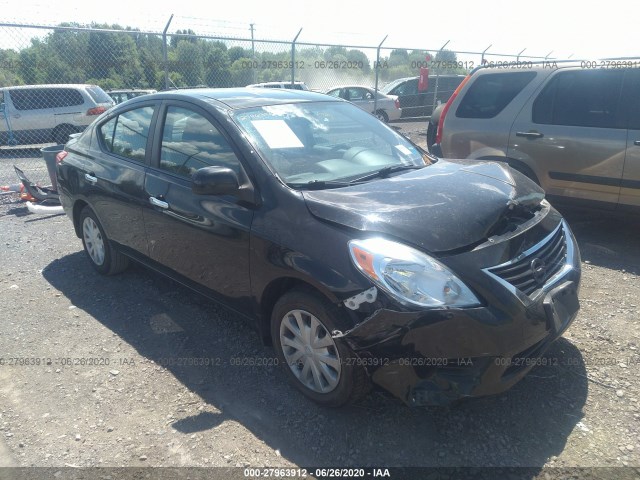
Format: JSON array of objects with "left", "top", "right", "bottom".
[{"left": 620, "top": 69, "right": 640, "bottom": 210}]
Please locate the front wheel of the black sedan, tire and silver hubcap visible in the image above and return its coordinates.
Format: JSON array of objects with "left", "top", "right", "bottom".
[{"left": 271, "top": 290, "right": 369, "bottom": 407}]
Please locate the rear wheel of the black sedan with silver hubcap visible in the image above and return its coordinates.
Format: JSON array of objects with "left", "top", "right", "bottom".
[{"left": 78, "top": 207, "right": 129, "bottom": 275}]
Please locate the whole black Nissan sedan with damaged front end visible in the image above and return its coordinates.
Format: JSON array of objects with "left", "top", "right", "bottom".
[{"left": 58, "top": 88, "right": 580, "bottom": 406}]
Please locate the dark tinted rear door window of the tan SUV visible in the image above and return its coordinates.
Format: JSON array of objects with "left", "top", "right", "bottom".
[{"left": 533, "top": 69, "right": 626, "bottom": 128}]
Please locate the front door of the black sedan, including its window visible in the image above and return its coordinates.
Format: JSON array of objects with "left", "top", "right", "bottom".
[{"left": 144, "top": 101, "right": 253, "bottom": 311}]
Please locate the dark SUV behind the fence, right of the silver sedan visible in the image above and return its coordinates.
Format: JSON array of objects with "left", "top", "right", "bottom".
[{"left": 380, "top": 75, "right": 465, "bottom": 118}]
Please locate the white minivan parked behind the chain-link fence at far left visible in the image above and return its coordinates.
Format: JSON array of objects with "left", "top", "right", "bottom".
[{"left": 0, "top": 84, "right": 114, "bottom": 145}]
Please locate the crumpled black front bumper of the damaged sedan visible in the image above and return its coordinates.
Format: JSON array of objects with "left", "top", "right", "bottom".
[{"left": 333, "top": 221, "right": 580, "bottom": 406}]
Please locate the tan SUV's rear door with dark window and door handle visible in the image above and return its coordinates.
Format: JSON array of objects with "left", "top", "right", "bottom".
[{"left": 508, "top": 69, "right": 627, "bottom": 208}]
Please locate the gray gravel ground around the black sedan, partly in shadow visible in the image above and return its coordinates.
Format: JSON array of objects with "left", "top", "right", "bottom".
[{"left": 0, "top": 124, "right": 640, "bottom": 478}]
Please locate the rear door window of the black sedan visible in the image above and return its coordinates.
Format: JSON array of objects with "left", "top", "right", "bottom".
[{"left": 98, "top": 106, "right": 154, "bottom": 162}]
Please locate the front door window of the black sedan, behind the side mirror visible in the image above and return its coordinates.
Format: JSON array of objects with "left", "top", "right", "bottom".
[{"left": 160, "top": 106, "right": 240, "bottom": 176}]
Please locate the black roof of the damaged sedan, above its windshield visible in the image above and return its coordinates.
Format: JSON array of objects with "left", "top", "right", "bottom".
[{"left": 140, "top": 87, "right": 340, "bottom": 110}]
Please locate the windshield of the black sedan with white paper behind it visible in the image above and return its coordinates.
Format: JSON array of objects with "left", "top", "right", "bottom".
[{"left": 234, "top": 102, "right": 430, "bottom": 187}]
